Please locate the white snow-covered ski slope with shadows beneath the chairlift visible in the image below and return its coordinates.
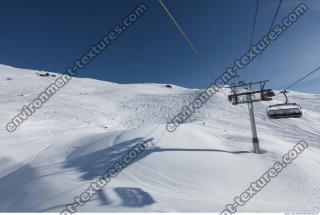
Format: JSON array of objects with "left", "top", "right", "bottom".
[{"left": 0, "top": 65, "right": 320, "bottom": 212}]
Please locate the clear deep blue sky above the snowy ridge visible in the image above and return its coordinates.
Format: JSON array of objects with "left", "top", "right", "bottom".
[{"left": 0, "top": 0, "right": 320, "bottom": 93}]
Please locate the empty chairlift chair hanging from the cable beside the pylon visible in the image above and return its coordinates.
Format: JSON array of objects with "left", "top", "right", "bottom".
[{"left": 266, "top": 90, "right": 302, "bottom": 119}]
